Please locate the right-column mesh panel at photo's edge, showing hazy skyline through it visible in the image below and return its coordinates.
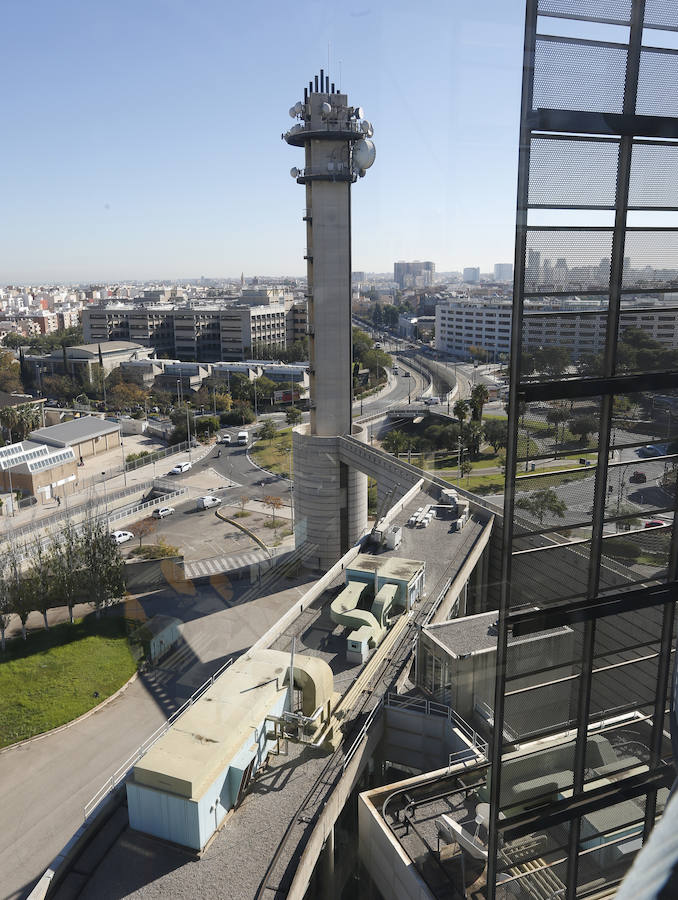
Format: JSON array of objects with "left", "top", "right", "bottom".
[{"left": 622, "top": 229, "right": 678, "bottom": 290}]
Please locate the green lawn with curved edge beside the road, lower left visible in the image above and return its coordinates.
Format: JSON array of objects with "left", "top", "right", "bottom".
[{"left": 0, "top": 616, "right": 136, "bottom": 747}]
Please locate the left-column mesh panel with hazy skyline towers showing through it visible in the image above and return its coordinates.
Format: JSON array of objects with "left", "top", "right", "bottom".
[{"left": 525, "top": 228, "right": 612, "bottom": 293}]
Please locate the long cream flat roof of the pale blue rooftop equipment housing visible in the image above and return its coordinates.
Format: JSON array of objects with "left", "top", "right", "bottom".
[{"left": 134, "top": 650, "right": 289, "bottom": 800}]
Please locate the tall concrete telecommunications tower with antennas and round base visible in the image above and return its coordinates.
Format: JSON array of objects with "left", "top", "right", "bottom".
[{"left": 283, "top": 69, "right": 375, "bottom": 565}]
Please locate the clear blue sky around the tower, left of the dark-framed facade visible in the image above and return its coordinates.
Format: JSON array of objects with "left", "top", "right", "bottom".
[{"left": 0, "top": 0, "right": 524, "bottom": 284}]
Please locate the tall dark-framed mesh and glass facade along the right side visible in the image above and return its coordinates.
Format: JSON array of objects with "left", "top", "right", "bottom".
[{"left": 488, "top": 0, "right": 678, "bottom": 898}]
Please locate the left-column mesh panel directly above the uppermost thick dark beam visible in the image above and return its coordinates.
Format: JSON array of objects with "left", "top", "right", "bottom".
[{"left": 532, "top": 37, "right": 626, "bottom": 113}]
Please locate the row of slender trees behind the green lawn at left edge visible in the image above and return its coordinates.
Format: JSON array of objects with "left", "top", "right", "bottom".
[{"left": 0, "top": 512, "right": 125, "bottom": 651}]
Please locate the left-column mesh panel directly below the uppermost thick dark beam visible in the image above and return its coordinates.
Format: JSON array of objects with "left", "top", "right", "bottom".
[{"left": 529, "top": 138, "right": 620, "bottom": 207}]
